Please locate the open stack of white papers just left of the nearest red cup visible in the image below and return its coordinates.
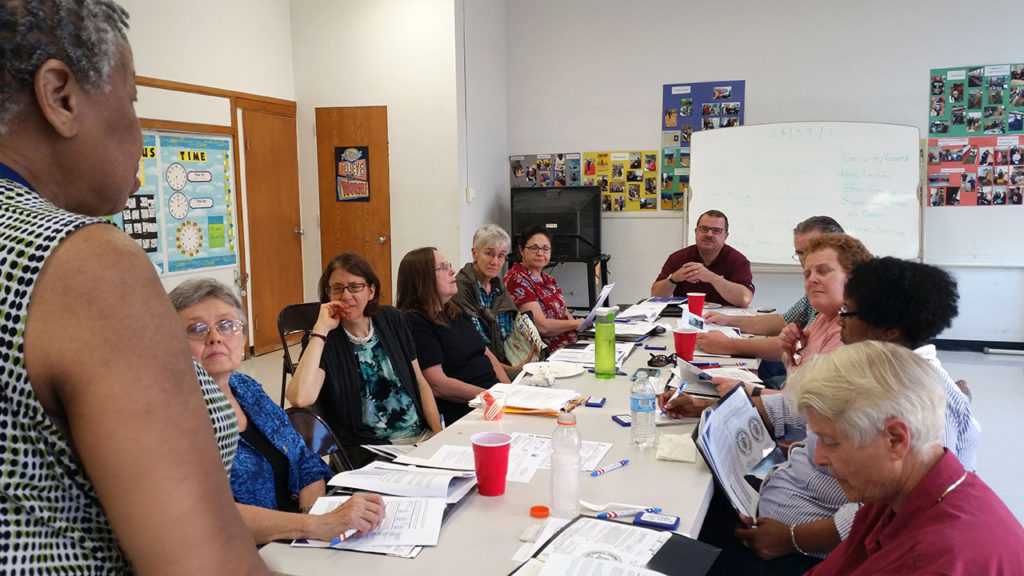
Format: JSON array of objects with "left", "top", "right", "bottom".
[{"left": 328, "top": 461, "right": 476, "bottom": 503}]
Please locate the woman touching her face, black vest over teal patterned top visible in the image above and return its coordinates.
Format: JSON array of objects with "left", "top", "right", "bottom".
[{"left": 285, "top": 252, "right": 441, "bottom": 447}]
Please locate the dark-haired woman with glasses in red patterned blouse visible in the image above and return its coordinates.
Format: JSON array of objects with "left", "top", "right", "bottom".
[{"left": 505, "top": 225, "right": 583, "bottom": 353}]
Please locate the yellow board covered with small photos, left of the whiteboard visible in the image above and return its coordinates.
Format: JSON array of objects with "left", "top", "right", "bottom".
[{"left": 583, "top": 150, "right": 658, "bottom": 212}]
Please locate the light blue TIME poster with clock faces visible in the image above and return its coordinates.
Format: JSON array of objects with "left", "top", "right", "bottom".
[{"left": 157, "top": 134, "right": 238, "bottom": 272}]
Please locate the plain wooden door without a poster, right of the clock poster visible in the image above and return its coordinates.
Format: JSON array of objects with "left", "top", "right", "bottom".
[{"left": 242, "top": 109, "right": 303, "bottom": 355}]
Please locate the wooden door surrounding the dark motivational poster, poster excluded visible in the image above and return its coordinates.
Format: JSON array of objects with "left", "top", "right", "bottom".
[{"left": 316, "top": 106, "right": 391, "bottom": 304}]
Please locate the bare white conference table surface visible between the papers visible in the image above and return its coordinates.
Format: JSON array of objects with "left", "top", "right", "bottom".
[{"left": 260, "top": 333, "right": 741, "bottom": 575}]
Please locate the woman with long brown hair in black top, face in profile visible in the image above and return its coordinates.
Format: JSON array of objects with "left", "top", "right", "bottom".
[{"left": 397, "top": 247, "right": 509, "bottom": 423}]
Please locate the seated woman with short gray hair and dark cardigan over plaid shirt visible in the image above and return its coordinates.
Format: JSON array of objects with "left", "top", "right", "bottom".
[{"left": 452, "top": 223, "right": 536, "bottom": 371}]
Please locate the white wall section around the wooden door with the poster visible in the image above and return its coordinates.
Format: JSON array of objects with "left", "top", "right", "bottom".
[{"left": 291, "top": 0, "right": 461, "bottom": 298}]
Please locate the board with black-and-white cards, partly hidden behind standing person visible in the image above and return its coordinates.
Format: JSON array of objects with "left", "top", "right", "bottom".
[{"left": 110, "top": 133, "right": 166, "bottom": 274}]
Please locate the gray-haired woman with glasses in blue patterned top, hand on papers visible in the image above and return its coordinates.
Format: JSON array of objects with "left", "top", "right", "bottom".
[{"left": 170, "top": 278, "right": 384, "bottom": 544}]
